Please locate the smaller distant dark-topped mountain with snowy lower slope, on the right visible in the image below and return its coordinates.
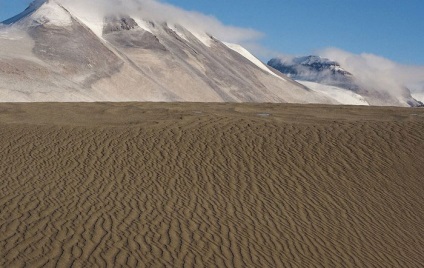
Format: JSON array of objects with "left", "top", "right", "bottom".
[{"left": 268, "top": 56, "right": 422, "bottom": 106}]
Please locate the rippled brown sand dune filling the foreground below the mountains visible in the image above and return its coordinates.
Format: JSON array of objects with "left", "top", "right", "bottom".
[{"left": 0, "top": 104, "right": 424, "bottom": 267}]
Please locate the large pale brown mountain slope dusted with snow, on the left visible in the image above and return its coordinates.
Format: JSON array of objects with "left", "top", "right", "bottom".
[{"left": 0, "top": 0, "right": 338, "bottom": 104}]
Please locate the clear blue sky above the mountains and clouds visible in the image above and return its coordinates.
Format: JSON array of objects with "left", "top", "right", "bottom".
[{"left": 0, "top": 0, "right": 424, "bottom": 65}]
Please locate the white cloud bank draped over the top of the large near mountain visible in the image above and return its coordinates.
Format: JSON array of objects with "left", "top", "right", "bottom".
[{"left": 56, "top": 0, "right": 263, "bottom": 43}]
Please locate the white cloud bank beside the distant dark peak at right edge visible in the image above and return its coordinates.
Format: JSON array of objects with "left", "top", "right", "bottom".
[{"left": 317, "top": 48, "right": 424, "bottom": 102}]
